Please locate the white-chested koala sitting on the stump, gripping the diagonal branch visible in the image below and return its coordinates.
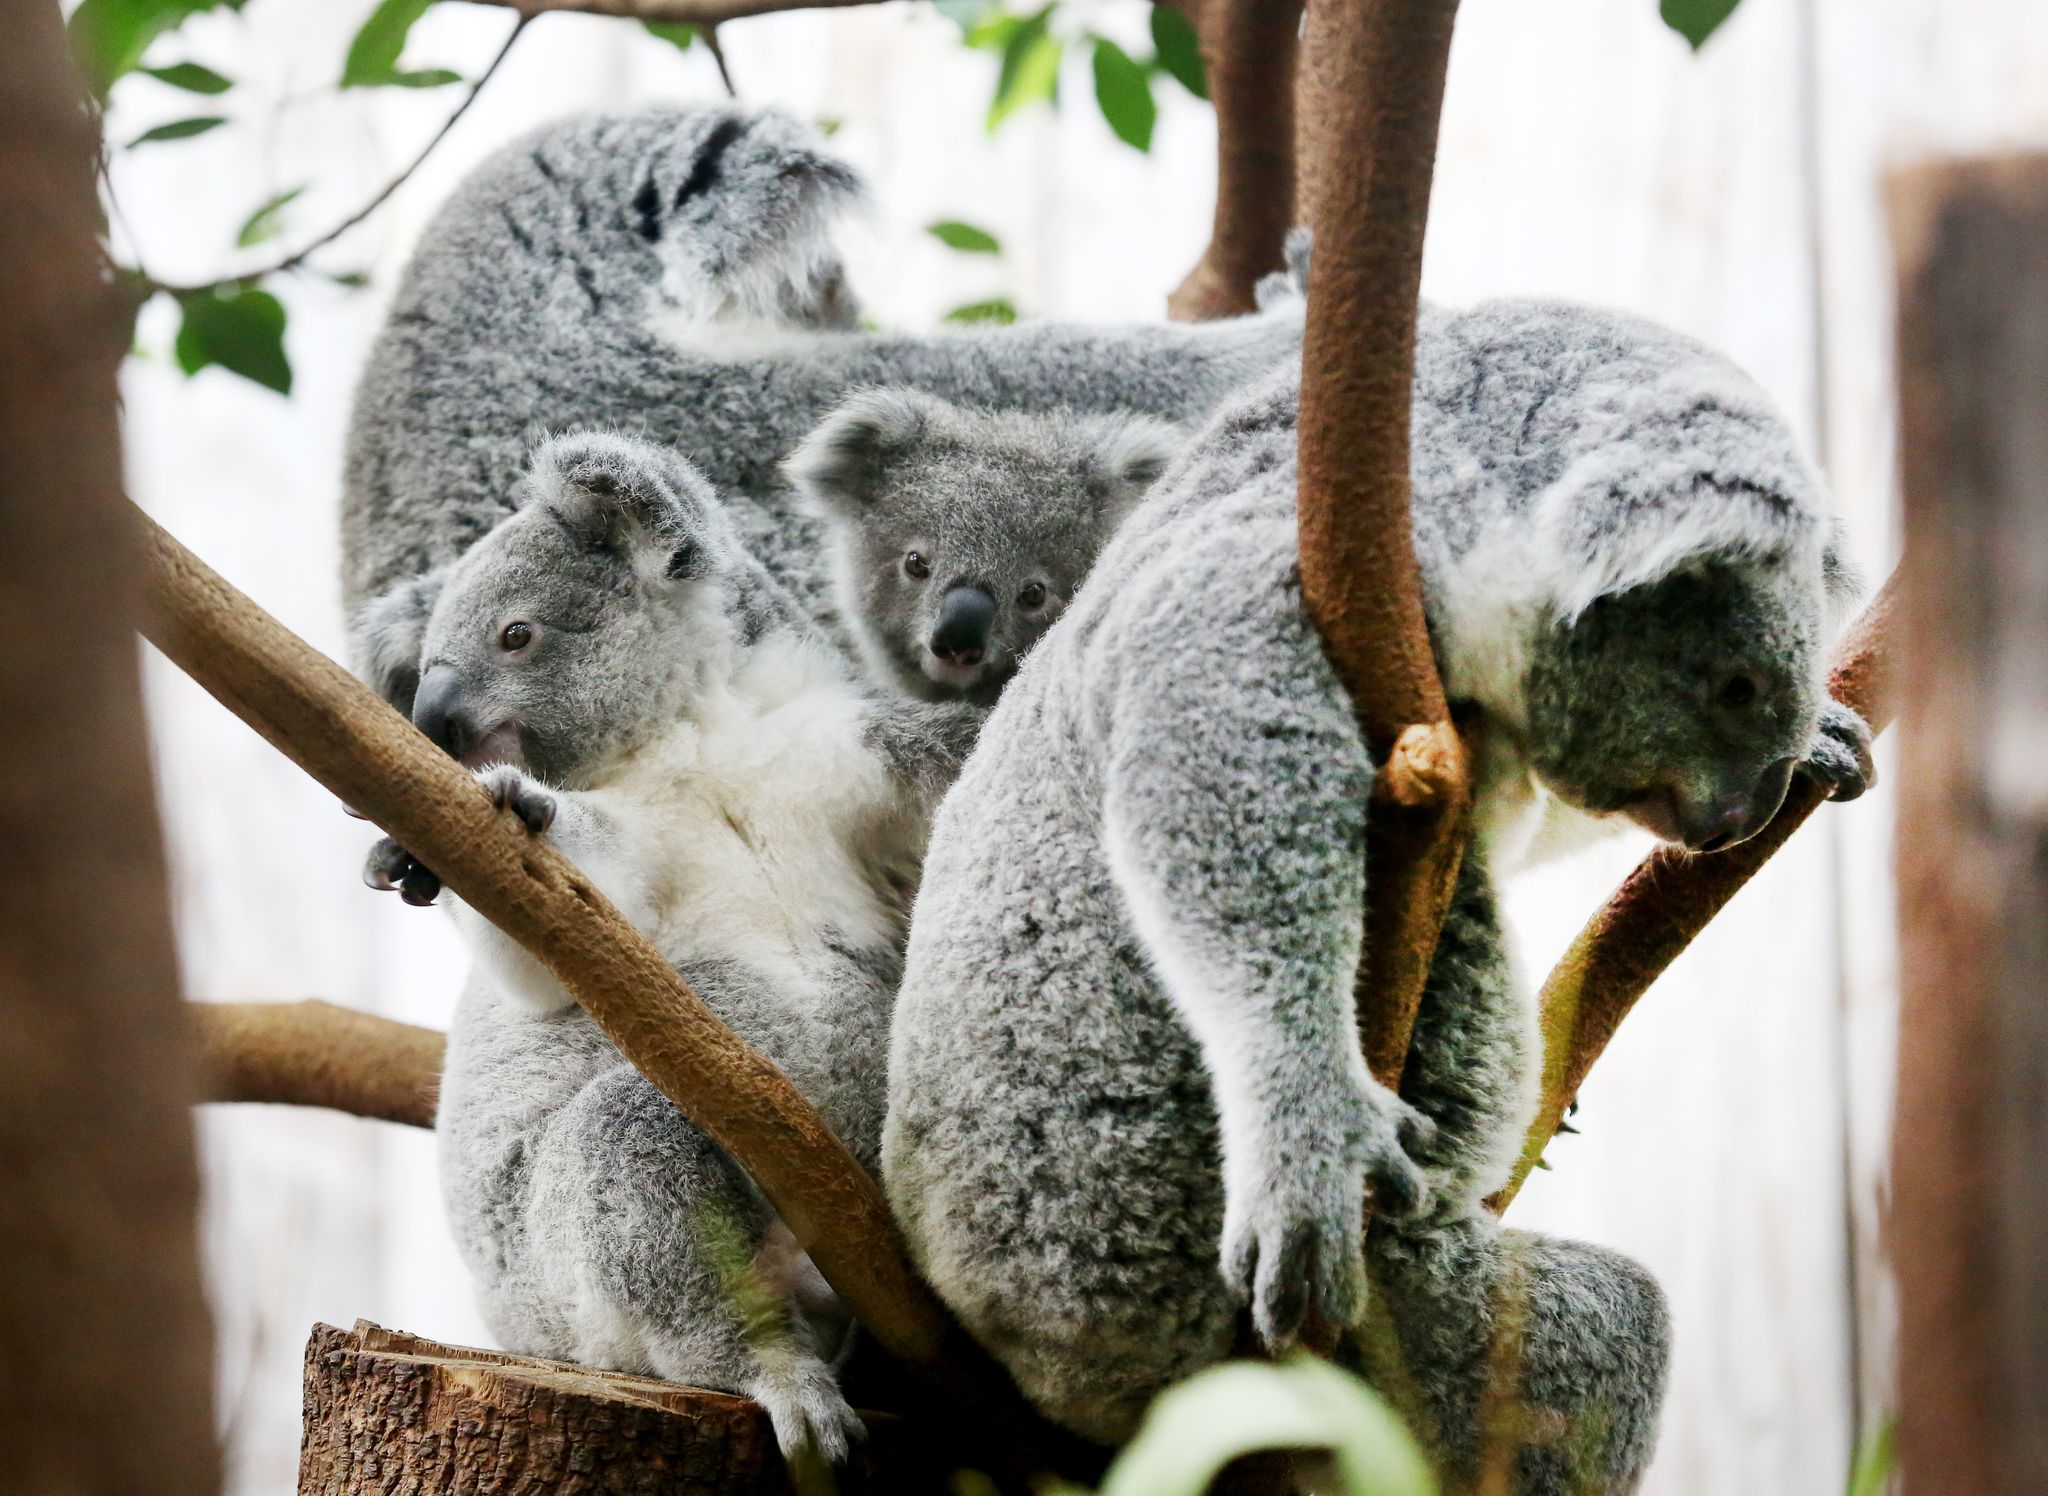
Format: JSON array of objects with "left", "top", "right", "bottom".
[{"left": 365, "top": 434, "right": 979, "bottom": 1459}]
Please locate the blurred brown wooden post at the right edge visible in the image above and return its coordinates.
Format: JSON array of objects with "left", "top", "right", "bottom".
[{"left": 1888, "top": 156, "right": 2048, "bottom": 1496}]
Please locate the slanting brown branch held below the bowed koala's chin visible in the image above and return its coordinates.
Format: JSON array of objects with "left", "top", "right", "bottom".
[{"left": 1487, "top": 576, "right": 1898, "bottom": 1211}]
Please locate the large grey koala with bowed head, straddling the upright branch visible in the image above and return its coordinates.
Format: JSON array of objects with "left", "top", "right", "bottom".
[{"left": 883, "top": 301, "right": 1870, "bottom": 1496}]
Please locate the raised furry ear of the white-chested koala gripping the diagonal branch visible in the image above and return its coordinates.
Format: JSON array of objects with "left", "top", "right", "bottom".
[{"left": 528, "top": 432, "right": 717, "bottom": 580}]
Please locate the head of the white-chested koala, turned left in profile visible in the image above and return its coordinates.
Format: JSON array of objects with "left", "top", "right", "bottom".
[{"left": 412, "top": 434, "right": 766, "bottom": 785}]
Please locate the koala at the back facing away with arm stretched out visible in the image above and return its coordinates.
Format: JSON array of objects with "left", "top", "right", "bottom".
[{"left": 342, "top": 107, "right": 1303, "bottom": 711}]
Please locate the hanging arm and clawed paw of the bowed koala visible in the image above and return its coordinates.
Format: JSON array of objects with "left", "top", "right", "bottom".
[{"left": 1096, "top": 522, "right": 1430, "bottom": 1344}]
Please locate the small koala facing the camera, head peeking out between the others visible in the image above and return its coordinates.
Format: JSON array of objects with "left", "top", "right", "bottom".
[{"left": 784, "top": 387, "right": 1186, "bottom": 707}]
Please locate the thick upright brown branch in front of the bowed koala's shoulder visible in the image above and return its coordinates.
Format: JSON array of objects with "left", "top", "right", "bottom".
[{"left": 1298, "top": 0, "right": 1470, "bottom": 1082}]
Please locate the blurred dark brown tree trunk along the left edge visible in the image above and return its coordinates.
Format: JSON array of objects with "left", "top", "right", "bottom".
[{"left": 0, "top": 0, "right": 219, "bottom": 1496}]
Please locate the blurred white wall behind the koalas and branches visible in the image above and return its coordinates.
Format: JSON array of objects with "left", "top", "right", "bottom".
[{"left": 109, "top": 0, "right": 2048, "bottom": 1496}]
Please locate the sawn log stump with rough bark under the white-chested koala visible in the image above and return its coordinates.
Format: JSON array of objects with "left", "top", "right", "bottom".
[{"left": 299, "top": 1320, "right": 950, "bottom": 1496}]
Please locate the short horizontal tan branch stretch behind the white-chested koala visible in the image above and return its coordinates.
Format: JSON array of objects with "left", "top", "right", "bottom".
[{"left": 186, "top": 1002, "right": 449, "bottom": 1127}]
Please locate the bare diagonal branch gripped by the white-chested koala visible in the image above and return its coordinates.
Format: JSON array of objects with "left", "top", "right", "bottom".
[{"left": 137, "top": 510, "right": 1073, "bottom": 1463}]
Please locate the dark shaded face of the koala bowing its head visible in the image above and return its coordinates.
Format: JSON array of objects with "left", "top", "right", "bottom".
[{"left": 1528, "top": 564, "right": 1823, "bottom": 853}]
